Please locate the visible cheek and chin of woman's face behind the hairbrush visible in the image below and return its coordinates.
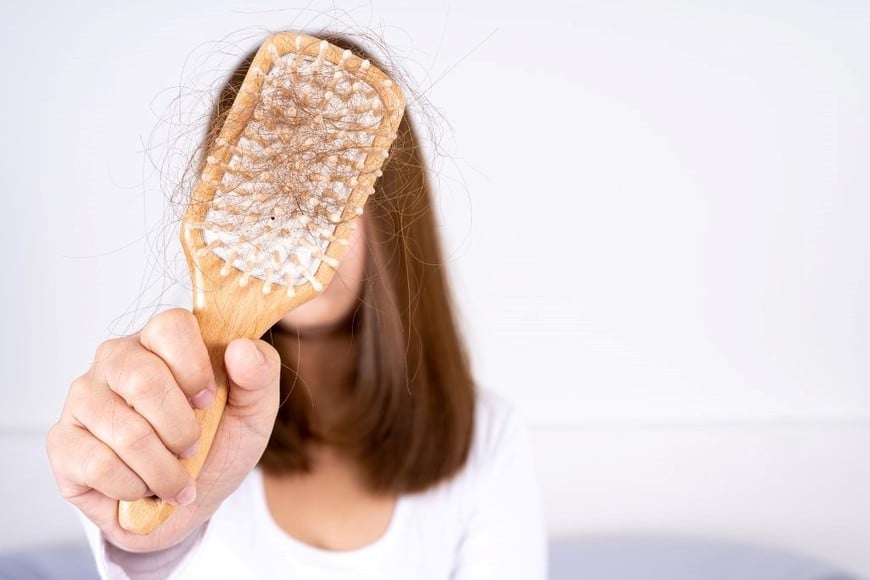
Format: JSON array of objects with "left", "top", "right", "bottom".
[{"left": 278, "top": 218, "right": 366, "bottom": 333}]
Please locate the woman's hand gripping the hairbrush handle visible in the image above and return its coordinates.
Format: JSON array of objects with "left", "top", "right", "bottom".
[{"left": 46, "top": 309, "right": 281, "bottom": 552}]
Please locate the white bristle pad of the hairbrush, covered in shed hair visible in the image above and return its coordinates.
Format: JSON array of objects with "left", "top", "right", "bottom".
[{"left": 198, "top": 53, "right": 387, "bottom": 286}]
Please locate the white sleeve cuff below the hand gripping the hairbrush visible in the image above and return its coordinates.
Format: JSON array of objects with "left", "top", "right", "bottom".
[{"left": 76, "top": 510, "right": 208, "bottom": 580}]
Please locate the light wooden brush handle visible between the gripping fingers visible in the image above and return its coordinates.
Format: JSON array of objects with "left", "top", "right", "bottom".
[{"left": 118, "top": 309, "right": 238, "bottom": 534}]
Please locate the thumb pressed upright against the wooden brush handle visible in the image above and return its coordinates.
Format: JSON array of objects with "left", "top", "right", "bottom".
[{"left": 224, "top": 338, "right": 281, "bottom": 422}]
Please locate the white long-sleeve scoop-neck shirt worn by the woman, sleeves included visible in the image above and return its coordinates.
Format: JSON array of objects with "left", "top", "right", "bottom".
[{"left": 83, "top": 391, "right": 546, "bottom": 580}]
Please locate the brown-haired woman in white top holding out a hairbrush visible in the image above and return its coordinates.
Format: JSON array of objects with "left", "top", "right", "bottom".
[{"left": 47, "top": 35, "right": 545, "bottom": 580}]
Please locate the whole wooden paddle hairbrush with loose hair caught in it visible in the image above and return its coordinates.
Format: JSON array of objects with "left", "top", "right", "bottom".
[{"left": 118, "top": 33, "right": 405, "bottom": 534}]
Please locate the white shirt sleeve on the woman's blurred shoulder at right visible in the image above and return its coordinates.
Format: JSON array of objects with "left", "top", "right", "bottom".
[{"left": 451, "top": 401, "right": 547, "bottom": 580}]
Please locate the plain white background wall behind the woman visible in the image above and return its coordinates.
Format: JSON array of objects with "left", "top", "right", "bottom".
[{"left": 0, "top": 0, "right": 870, "bottom": 575}]
